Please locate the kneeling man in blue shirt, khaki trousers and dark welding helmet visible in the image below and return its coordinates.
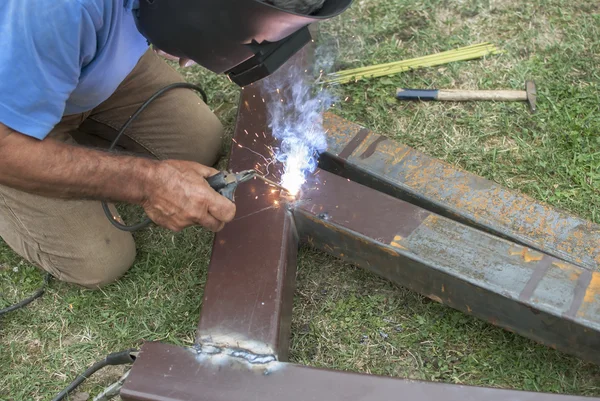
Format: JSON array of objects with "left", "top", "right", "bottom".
[{"left": 0, "top": 0, "right": 350, "bottom": 288}]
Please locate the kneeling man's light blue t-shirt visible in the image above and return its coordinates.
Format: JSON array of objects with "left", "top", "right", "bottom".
[{"left": 0, "top": 0, "right": 148, "bottom": 139}]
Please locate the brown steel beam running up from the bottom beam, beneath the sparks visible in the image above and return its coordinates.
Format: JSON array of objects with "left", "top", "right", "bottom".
[{"left": 197, "top": 50, "right": 310, "bottom": 361}]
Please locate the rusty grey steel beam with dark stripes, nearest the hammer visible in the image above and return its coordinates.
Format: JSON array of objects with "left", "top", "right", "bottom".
[{"left": 321, "top": 114, "right": 600, "bottom": 272}]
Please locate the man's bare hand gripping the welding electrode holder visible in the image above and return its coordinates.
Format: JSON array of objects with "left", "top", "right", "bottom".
[{"left": 142, "top": 160, "right": 235, "bottom": 232}]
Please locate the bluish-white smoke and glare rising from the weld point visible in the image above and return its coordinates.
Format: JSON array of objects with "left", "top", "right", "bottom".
[{"left": 264, "top": 67, "right": 333, "bottom": 195}]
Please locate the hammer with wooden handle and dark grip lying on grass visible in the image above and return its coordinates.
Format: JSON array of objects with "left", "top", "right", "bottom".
[{"left": 396, "top": 81, "right": 537, "bottom": 112}]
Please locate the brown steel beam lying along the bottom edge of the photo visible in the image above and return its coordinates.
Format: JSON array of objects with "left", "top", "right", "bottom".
[{"left": 121, "top": 343, "right": 589, "bottom": 401}]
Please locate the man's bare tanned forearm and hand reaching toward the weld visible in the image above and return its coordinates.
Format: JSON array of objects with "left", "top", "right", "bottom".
[{"left": 0, "top": 124, "right": 235, "bottom": 231}]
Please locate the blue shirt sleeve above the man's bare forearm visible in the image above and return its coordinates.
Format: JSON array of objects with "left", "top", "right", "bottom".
[{"left": 0, "top": 0, "right": 98, "bottom": 139}]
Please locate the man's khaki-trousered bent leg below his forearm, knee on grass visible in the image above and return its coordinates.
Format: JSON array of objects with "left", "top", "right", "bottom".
[{"left": 0, "top": 186, "right": 135, "bottom": 288}]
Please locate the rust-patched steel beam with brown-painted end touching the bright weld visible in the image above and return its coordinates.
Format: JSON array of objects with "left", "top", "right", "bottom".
[{"left": 294, "top": 170, "right": 600, "bottom": 363}]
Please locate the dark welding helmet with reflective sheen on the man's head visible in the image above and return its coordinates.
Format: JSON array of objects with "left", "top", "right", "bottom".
[{"left": 135, "top": 0, "right": 352, "bottom": 86}]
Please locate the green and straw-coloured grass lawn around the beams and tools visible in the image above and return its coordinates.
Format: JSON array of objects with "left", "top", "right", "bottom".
[{"left": 0, "top": 0, "right": 600, "bottom": 400}]
